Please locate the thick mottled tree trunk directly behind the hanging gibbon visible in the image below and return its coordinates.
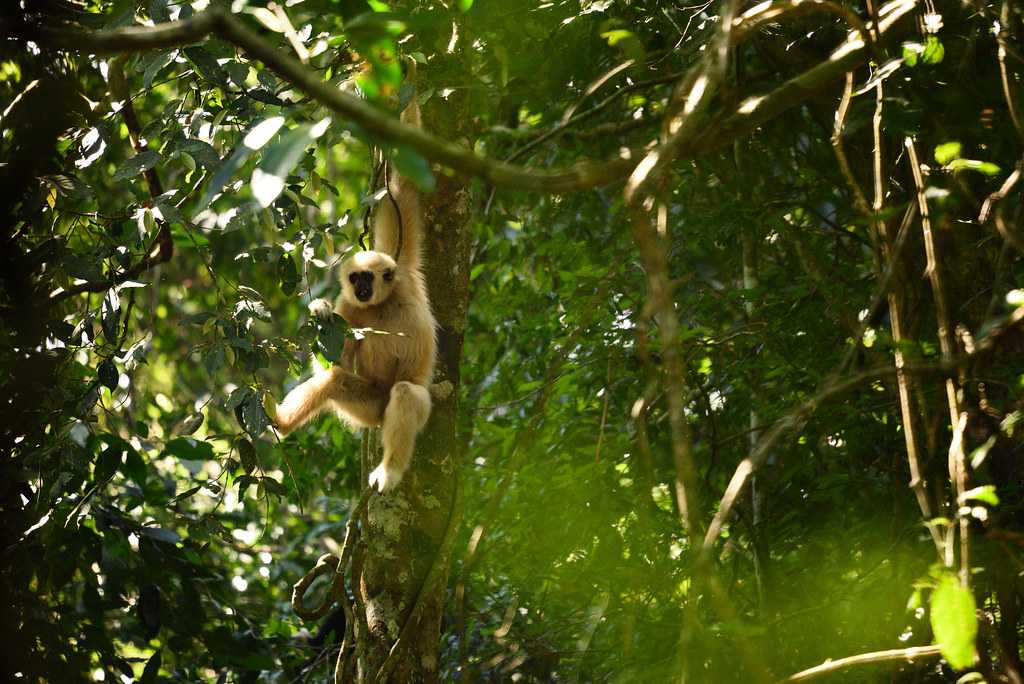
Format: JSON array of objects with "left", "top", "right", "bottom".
[{"left": 356, "top": 98, "right": 472, "bottom": 682}]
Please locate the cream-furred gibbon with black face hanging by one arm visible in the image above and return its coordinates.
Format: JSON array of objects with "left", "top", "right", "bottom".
[{"left": 273, "top": 97, "right": 437, "bottom": 493}]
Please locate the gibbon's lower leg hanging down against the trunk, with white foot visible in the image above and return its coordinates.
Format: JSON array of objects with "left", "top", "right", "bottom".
[{"left": 370, "top": 382, "right": 430, "bottom": 494}]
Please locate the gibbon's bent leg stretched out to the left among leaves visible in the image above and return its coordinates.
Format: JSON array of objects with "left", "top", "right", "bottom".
[{"left": 271, "top": 366, "right": 387, "bottom": 435}]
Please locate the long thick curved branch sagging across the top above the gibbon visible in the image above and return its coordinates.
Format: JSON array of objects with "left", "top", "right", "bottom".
[{"left": 9, "top": 0, "right": 915, "bottom": 194}]
